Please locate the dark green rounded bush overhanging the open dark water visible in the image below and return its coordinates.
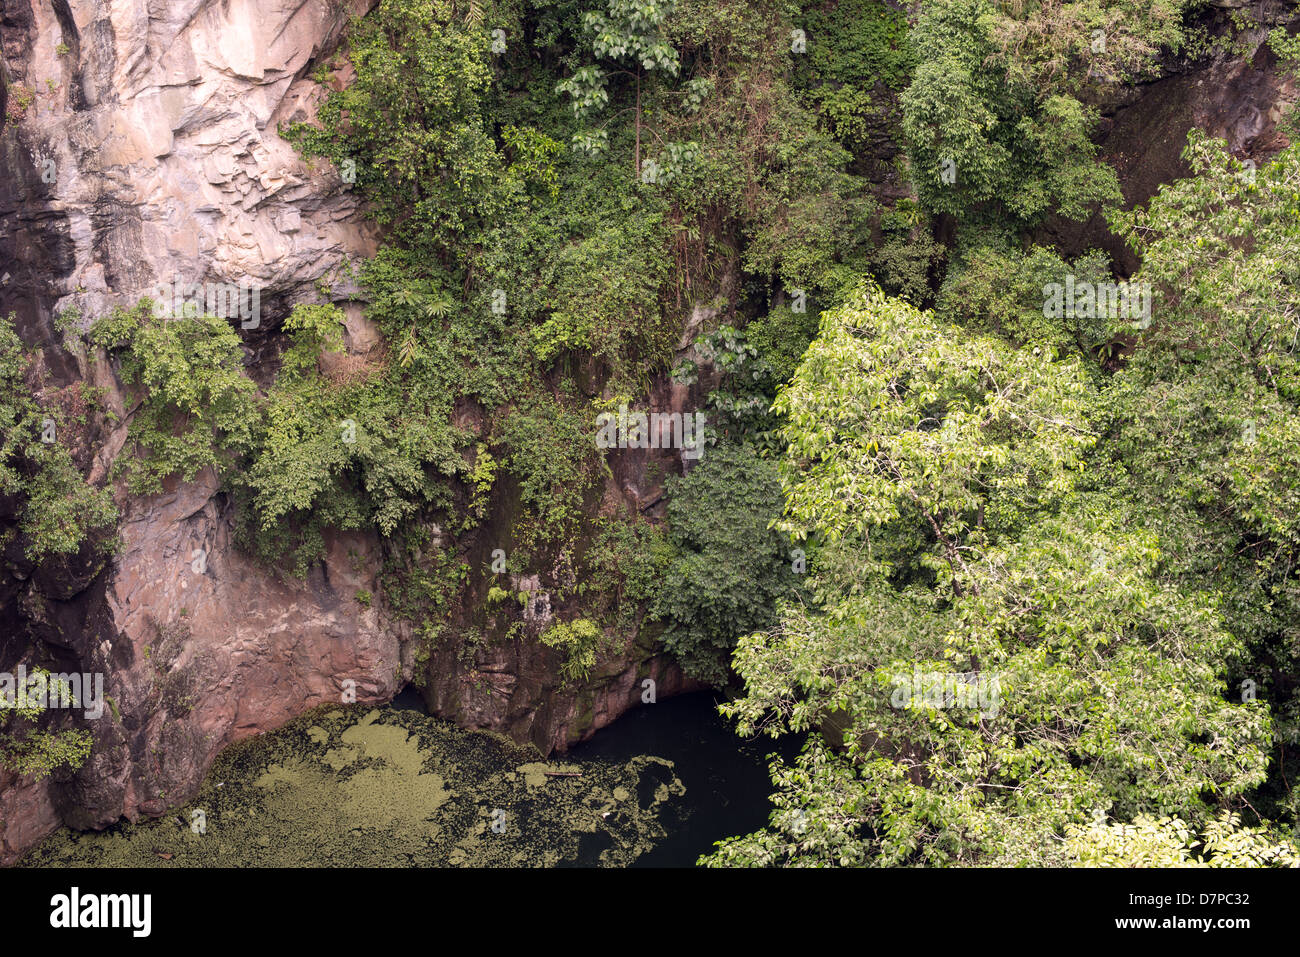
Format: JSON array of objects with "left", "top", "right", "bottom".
[{"left": 650, "top": 446, "right": 794, "bottom": 685}]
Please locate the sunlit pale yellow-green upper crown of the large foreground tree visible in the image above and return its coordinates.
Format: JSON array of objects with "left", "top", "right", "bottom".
[{"left": 776, "top": 289, "right": 1093, "bottom": 553}]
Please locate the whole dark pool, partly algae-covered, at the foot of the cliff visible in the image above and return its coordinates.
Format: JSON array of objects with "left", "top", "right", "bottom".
[{"left": 26, "top": 692, "right": 798, "bottom": 867}]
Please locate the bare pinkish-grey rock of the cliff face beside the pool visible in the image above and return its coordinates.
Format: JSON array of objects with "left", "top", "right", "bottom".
[{"left": 0, "top": 0, "right": 702, "bottom": 863}]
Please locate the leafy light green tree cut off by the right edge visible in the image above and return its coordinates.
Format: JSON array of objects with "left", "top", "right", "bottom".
[{"left": 1110, "top": 131, "right": 1300, "bottom": 814}]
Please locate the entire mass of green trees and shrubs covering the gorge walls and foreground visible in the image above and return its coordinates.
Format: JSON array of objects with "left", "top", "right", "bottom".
[{"left": 0, "top": 0, "right": 1300, "bottom": 865}]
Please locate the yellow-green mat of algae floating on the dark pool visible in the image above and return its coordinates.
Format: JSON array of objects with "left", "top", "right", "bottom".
[{"left": 23, "top": 707, "right": 685, "bottom": 867}]
